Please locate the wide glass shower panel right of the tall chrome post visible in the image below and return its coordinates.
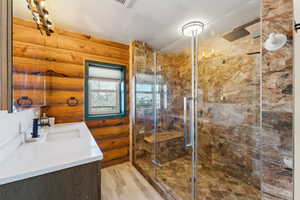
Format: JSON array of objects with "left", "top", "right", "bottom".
[{"left": 197, "top": 10, "right": 262, "bottom": 200}]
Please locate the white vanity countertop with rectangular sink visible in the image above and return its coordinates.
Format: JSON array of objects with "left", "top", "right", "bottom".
[{"left": 0, "top": 122, "right": 103, "bottom": 185}]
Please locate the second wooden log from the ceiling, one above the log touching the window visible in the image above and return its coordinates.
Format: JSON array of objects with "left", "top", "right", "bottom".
[{"left": 13, "top": 24, "right": 129, "bottom": 60}]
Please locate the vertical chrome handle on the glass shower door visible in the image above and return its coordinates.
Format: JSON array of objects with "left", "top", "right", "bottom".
[{"left": 183, "top": 97, "right": 193, "bottom": 148}]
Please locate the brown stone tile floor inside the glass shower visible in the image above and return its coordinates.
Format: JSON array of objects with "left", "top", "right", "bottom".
[{"left": 136, "top": 156, "right": 261, "bottom": 200}]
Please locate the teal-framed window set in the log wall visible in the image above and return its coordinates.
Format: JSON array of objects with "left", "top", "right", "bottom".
[{"left": 85, "top": 61, "right": 125, "bottom": 119}]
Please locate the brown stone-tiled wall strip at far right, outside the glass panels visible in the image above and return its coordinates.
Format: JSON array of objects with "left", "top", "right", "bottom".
[{"left": 261, "top": 0, "right": 294, "bottom": 200}]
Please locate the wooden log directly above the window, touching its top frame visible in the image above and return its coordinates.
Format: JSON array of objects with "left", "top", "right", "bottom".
[{"left": 13, "top": 41, "right": 128, "bottom": 66}]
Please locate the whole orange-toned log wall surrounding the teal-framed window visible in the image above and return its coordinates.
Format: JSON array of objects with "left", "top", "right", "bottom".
[{"left": 13, "top": 18, "right": 129, "bottom": 167}]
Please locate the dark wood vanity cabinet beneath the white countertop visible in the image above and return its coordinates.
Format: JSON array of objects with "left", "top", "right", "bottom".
[{"left": 0, "top": 162, "right": 101, "bottom": 200}]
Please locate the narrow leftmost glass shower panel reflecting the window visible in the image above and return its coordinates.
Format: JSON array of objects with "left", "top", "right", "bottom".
[{"left": 133, "top": 42, "right": 155, "bottom": 179}]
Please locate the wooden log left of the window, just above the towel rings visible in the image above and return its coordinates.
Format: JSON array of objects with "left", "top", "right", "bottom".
[{"left": 13, "top": 73, "right": 84, "bottom": 91}]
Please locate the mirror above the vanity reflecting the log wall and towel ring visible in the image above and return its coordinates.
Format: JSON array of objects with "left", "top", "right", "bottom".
[{"left": 12, "top": 0, "right": 49, "bottom": 111}]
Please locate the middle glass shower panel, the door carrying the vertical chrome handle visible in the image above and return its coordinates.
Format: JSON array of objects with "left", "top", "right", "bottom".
[{"left": 153, "top": 52, "right": 193, "bottom": 200}]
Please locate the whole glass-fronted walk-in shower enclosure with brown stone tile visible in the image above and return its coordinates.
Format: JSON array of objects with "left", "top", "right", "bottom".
[{"left": 132, "top": 1, "right": 262, "bottom": 200}]
